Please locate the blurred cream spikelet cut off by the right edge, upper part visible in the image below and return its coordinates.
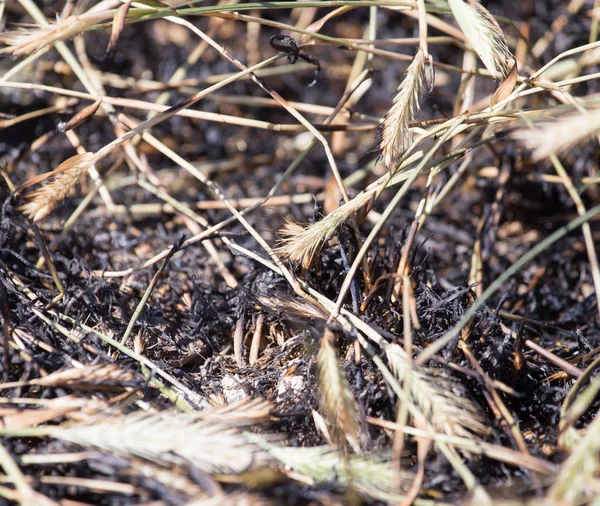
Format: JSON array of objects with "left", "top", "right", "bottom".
[{"left": 513, "top": 109, "right": 600, "bottom": 160}]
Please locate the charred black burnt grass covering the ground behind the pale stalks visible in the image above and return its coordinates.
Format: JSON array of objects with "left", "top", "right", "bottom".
[{"left": 0, "top": 1, "right": 600, "bottom": 505}]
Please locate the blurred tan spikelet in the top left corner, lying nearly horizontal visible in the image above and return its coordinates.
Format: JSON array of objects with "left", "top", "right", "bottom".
[{"left": 0, "top": 11, "right": 113, "bottom": 56}]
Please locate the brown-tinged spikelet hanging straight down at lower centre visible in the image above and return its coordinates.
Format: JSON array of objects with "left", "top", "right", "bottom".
[{"left": 317, "top": 328, "right": 360, "bottom": 453}]
